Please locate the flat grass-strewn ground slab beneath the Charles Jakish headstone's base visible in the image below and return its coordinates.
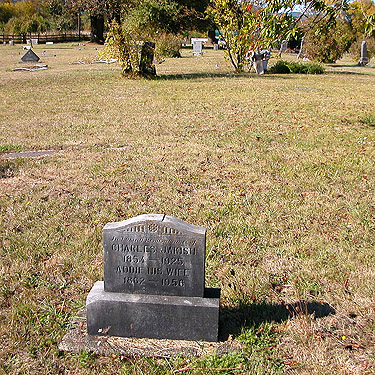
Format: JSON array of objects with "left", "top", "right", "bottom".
[{"left": 59, "top": 310, "right": 243, "bottom": 358}]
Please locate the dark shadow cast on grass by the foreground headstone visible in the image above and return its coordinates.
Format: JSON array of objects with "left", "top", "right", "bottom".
[{"left": 219, "top": 301, "right": 336, "bottom": 341}]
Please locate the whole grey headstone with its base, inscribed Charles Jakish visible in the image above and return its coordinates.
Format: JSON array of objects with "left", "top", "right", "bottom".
[{"left": 86, "top": 214, "right": 220, "bottom": 341}]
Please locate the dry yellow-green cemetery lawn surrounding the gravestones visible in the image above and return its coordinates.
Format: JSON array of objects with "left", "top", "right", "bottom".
[{"left": 0, "top": 44, "right": 375, "bottom": 375}]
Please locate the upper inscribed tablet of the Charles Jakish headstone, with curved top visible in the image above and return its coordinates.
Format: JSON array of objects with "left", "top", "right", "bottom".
[{"left": 103, "top": 214, "right": 206, "bottom": 297}]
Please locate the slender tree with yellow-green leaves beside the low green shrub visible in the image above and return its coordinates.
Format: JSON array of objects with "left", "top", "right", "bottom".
[{"left": 207, "top": 0, "right": 352, "bottom": 71}]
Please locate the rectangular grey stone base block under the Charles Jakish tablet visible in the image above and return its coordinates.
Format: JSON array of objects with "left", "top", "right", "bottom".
[{"left": 86, "top": 281, "right": 220, "bottom": 341}]
